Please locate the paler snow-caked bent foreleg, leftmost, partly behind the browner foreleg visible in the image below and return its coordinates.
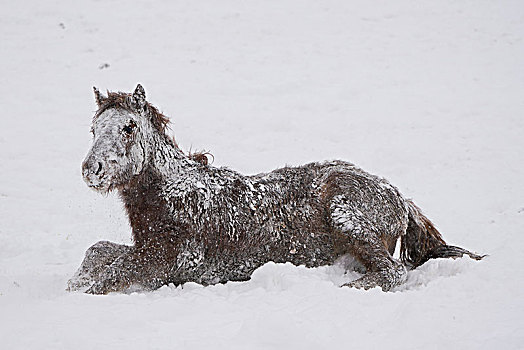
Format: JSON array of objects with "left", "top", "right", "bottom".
[{"left": 67, "top": 241, "right": 132, "bottom": 291}]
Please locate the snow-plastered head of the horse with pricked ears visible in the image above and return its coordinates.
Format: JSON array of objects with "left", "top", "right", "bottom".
[{"left": 82, "top": 84, "right": 168, "bottom": 193}]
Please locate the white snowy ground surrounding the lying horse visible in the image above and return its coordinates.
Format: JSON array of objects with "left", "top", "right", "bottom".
[{"left": 0, "top": 0, "right": 524, "bottom": 349}]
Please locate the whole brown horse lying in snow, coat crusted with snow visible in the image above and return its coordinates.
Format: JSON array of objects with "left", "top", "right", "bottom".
[{"left": 68, "top": 84, "right": 483, "bottom": 294}]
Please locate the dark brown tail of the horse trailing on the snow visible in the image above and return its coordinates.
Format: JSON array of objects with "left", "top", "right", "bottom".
[{"left": 400, "top": 200, "right": 484, "bottom": 268}]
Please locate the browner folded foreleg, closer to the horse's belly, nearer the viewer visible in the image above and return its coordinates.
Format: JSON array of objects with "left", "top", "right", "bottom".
[{"left": 86, "top": 248, "right": 170, "bottom": 294}]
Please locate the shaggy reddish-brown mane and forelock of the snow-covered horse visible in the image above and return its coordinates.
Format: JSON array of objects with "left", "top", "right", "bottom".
[{"left": 93, "top": 91, "right": 211, "bottom": 165}]
